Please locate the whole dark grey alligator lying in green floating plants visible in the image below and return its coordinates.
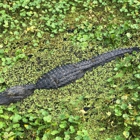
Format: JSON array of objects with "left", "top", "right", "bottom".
[{"left": 0, "top": 47, "right": 140, "bottom": 105}]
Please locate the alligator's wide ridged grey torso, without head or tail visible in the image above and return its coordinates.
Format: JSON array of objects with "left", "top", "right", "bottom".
[{"left": 36, "top": 64, "right": 85, "bottom": 89}]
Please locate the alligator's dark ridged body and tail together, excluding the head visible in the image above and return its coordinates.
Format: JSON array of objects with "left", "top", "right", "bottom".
[{"left": 36, "top": 47, "right": 140, "bottom": 89}]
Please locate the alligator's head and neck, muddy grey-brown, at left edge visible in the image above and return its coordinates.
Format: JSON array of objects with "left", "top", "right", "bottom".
[{"left": 0, "top": 84, "right": 35, "bottom": 105}]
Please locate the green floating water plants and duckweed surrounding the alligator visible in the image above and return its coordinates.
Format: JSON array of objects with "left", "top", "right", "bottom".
[{"left": 0, "top": 0, "right": 140, "bottom": 140}]
